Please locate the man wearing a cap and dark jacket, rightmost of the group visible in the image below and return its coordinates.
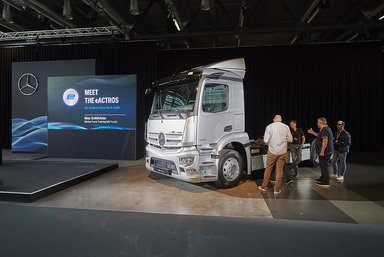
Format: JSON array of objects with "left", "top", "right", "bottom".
[{"left": 332, "top": 120, "right": 351, "bottom": 181}]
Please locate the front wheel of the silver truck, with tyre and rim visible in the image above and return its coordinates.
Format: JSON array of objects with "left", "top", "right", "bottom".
[{"left": 216, "top": 149, "right": 244, "bottom": 188}]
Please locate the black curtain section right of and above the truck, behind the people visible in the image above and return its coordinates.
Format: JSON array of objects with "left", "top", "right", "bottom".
[{"left": 157, "top": 43, "right": 384, "bottom": 152}]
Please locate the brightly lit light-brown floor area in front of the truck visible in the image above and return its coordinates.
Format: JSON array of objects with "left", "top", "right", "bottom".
[{"left": 28, "top": 161, "right": 272, "bottom": 218}]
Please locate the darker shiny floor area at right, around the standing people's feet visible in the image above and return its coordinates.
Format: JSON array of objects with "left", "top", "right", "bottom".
[{"left": 255, "top": 165, "right": 384, "bottom": 224}]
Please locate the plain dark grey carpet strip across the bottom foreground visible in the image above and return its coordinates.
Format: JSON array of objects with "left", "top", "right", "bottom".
[{"left": 0, "top": 203, "right": 384, "bottom": 257}]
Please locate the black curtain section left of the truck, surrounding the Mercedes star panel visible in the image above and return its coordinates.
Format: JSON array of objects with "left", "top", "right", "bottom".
[{"left": 0, "top": 42, "right": 157, "bottom": 157}]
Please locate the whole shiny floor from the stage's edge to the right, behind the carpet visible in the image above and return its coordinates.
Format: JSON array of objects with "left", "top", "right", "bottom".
[{"left": 0, "top": 151, "right": 384, "bottom": 224}]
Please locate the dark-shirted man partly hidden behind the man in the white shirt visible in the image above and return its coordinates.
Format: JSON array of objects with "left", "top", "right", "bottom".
[{"left": 287, "top": 120, "right": 305, "bottom": 179}]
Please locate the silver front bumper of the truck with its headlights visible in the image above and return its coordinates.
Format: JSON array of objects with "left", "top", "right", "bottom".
[{"left": 145, "top": 145, "right": 217, "bottom": 183}]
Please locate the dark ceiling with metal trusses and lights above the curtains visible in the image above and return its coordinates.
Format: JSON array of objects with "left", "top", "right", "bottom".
[{"left": 0, "top": 0, "right": 384, "bottom": 48}]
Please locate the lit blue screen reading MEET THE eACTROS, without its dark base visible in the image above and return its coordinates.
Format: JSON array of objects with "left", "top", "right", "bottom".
[{"left": 48, "top": 75, "right": 136, "bottom": 130}]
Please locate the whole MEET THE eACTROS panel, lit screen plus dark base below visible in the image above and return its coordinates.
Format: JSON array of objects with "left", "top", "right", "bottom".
[{"left": 48, "top": 75, "right": 136, "bottom": 160}]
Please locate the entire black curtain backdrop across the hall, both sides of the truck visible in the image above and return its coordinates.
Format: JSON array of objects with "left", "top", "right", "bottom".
[{"left": 0, "top": 42, "right": 384, "bottom": 156}]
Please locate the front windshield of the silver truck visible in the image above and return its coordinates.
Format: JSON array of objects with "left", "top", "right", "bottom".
[{"left": 152, "top": 80, "right": 199, "bottom": 113}]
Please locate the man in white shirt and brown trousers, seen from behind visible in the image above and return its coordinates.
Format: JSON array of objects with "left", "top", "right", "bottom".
[{"left": 258, "top": 115, "right": 292, "bottom": 195}]
